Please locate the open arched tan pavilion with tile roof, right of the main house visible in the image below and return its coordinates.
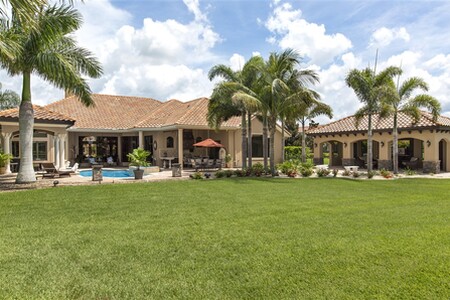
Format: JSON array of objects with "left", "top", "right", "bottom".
[{"left": 308, "top": 112, "right": 450, "bottom": 173}]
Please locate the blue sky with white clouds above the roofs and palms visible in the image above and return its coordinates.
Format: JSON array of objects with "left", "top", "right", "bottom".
[{"left": 0, "top": 0, "right": 450, "bottom": 123}]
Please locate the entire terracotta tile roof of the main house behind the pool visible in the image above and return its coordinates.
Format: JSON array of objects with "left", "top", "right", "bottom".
[{"left": 46, "top": 94, "right": 240, "bottom": 129}]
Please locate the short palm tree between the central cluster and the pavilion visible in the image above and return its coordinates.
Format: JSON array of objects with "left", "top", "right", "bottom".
[{"left": 291, "top": 92, "right": 333, "bottom": 162}]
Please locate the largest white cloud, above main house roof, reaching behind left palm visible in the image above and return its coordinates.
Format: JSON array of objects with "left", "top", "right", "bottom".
[{"left": 0, "top": 0, "right": 221, "bottom": 105}]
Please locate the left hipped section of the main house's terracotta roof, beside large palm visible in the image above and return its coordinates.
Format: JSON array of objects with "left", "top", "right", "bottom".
[{"left": 46, "top": 94, "right": 162, "bottom": 129}]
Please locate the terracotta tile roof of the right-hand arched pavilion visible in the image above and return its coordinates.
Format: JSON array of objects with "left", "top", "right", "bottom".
[{"left": 308, "top": 111, "right": 450, "bottom": 135}]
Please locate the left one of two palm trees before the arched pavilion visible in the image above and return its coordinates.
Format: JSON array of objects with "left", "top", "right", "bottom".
[{"left": 345, "top": 67, "right": 401, "bottom": 172}]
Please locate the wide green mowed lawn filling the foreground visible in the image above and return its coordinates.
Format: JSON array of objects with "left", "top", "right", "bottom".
[{"left": 0, "top": 178, "right": 450, "bottom": 299}]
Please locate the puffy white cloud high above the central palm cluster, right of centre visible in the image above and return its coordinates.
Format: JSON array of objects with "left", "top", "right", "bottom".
[{"left": 266, "top": 3, "right": 352, "bottom": 65}]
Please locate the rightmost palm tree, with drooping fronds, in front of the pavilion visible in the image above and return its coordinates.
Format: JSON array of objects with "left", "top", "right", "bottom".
[{"left": 381, "top": 75, "right": 441, "bottom": 174}]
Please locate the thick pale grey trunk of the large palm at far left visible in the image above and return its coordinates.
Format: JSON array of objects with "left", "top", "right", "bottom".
[{"left": 16, "top": 72, "right": 36, "bottom": 183}]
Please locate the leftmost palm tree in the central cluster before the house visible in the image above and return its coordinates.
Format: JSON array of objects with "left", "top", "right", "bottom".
[{"left": 208, "top": 56, "right": 263, "bottom": 168}]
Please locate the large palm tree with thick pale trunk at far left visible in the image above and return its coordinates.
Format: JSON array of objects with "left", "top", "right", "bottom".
[{"left": 0, "top": 6, "right": 102, "bottom": 183}]
